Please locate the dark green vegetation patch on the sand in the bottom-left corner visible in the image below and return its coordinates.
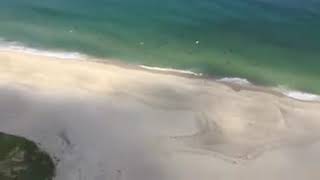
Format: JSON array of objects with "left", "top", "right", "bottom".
[{"left": 0, "top": 132, "right": 55, "bottom": 180}]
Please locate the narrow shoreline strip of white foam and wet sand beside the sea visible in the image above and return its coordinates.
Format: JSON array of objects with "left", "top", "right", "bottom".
[{"left": 0, "top": 43, "right": 320, "bottom": 103}]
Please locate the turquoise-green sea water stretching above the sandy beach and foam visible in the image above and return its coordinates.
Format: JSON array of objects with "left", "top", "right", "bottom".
[{"left": 0, "top": 0, "right": 320, "bottom": 94}]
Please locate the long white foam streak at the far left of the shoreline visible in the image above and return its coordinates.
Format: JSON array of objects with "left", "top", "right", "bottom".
[{"left": 0, "top": 38, "right": 85, "bottom": 59}]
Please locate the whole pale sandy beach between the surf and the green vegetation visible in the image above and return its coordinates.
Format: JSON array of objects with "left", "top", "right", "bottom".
[{"left": 0, "top": 51, "right": 320, "bottom": 180}]
